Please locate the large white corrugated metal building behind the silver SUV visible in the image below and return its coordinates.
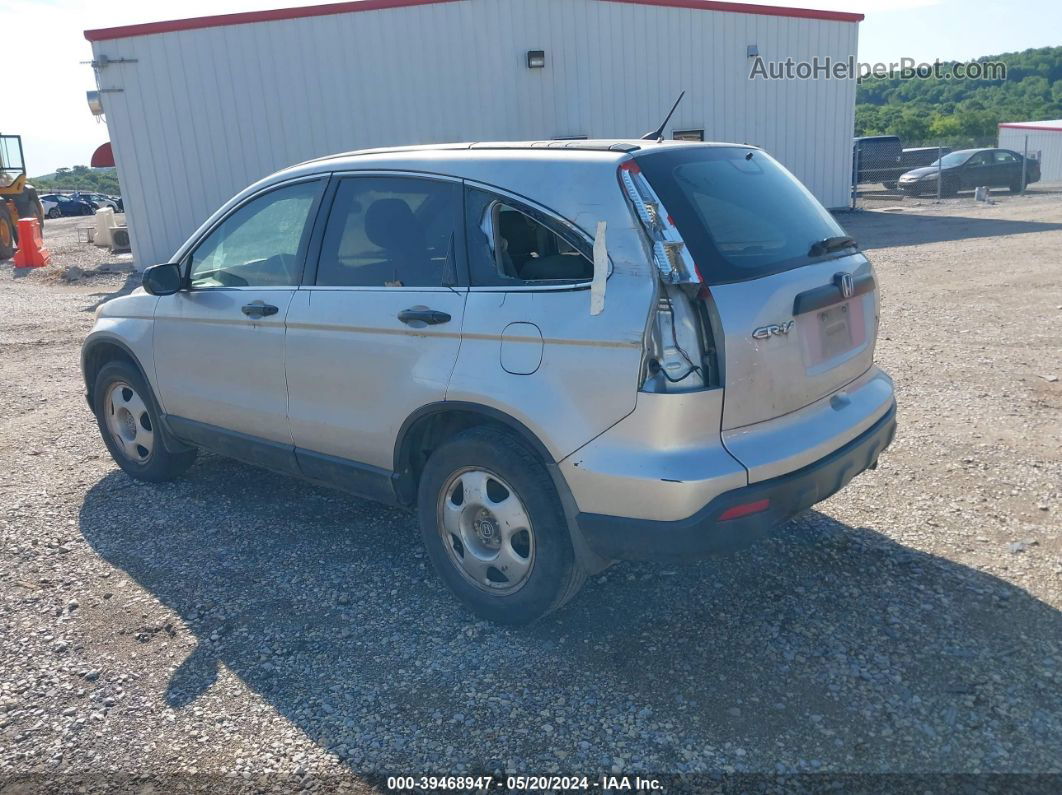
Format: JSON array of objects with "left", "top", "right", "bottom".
[{"left": 85, "top": 0, "right": 862, "bottom": 266}]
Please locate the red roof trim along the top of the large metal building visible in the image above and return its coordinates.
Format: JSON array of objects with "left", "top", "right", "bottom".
[{"left": 85, "top": 0, "right": 863, "bottom": 41}]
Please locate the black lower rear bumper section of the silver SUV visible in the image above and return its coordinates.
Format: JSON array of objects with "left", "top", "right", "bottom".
[{"left": 576, "top": 403, "right": 896, "bottom": 560}]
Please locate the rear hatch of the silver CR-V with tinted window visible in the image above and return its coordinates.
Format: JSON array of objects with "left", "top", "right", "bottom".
[{"left": 638, "top": 146, "right": 891, "bottom": 480}]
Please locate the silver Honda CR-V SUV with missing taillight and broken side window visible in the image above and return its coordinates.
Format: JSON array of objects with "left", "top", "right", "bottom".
[{"left": 82, "top": 141, "right": 895, "bottom": 623}]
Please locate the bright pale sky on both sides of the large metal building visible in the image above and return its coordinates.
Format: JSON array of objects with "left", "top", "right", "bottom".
[{"left": 6, "top": 0, "right": 1062, "bottom": 176}]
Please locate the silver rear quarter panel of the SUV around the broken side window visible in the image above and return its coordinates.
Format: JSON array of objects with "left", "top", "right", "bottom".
[{"left": 446, "top": 152, "right": 655, "bottom": 461}]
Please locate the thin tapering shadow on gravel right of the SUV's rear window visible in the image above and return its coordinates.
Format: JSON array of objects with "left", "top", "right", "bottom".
[{"left": 839, "top": 209, "right": 1062, "bottom": 250}]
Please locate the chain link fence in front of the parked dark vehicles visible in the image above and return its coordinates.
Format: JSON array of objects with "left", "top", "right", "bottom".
[{"left": 852, "top": 136, "right": 1040, "bottom": 207}]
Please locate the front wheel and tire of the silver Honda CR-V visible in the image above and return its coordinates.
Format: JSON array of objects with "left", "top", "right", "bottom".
[{"left": 92, "top": 361, "right": 196, "bottom": 483}]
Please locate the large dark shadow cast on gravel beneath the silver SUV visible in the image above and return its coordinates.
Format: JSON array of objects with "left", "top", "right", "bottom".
[{"left": 80, "top": 455, "right": 1062, "bottom": 774}]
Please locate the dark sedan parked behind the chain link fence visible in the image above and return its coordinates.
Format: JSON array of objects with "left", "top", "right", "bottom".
[{"left": 900, "top": 149, "right": 1040, "bottom": 196}]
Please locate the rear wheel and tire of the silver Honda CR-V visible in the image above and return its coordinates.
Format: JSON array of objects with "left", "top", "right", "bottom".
[{"left": 417, "top": 427, "right": 586, "bottom": 624}]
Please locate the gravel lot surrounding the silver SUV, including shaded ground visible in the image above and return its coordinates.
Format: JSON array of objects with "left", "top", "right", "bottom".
[{"left": 0, "top": 195, "right": 1062, "bottom": 790}]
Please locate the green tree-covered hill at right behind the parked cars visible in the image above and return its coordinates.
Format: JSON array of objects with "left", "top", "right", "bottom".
[{"left": 855, "top": 47, "right": 1062, "bottom": 146}]
